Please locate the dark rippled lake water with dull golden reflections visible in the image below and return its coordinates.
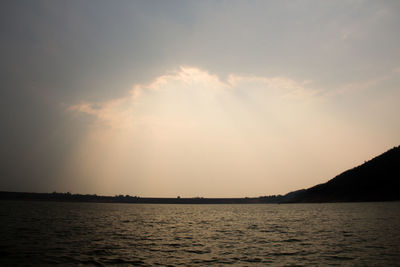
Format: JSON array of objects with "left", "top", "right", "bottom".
[{"left": 0, "top": 201, "right": 400, "bottom": 266}]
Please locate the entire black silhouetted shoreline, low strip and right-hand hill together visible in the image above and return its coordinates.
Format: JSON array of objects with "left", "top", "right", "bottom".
[{"left": 0, "top": 146, "right": 400, "bottom": 204}]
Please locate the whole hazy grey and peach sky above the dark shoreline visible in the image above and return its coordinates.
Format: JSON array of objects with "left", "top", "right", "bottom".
[{"left": 0, "top": 0, "right": 400, "bottom": 197}]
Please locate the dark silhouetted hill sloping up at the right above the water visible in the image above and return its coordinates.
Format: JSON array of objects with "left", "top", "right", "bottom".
[{"left": 283, "top": 146, "right": 400, "bottom": 203}]
